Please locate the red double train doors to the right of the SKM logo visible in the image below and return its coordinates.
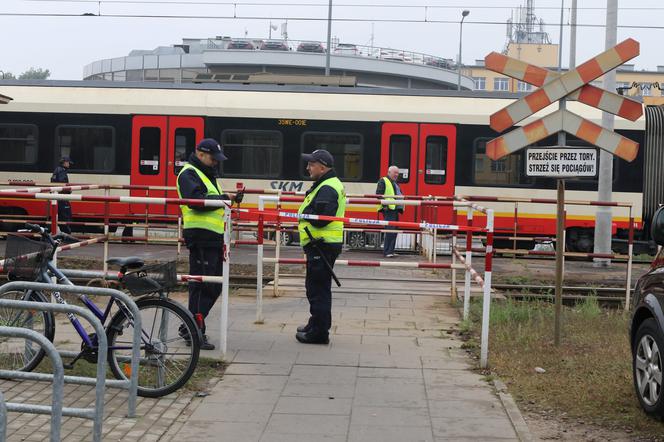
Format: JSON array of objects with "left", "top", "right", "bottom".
[{"left": 380, "top": 123, "right": 456, "bottom": 222}]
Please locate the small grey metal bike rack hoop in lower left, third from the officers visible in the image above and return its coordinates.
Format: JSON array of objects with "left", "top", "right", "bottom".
[{"left": 0, "top": 324, "right": 66, "bottom": 442}]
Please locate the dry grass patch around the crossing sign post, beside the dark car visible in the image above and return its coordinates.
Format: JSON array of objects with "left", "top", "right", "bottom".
[{"left": 461, "top": 296, "right": 664, "bottom": 440}]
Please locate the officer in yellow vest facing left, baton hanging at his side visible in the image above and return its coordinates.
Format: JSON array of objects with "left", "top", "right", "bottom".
[{"left": 295, "top": 149, "right": 346, "bottom": 344}]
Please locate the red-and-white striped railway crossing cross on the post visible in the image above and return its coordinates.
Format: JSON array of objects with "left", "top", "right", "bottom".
[{"left": 484, "top": 38, "right": 643, "bottom": 161}]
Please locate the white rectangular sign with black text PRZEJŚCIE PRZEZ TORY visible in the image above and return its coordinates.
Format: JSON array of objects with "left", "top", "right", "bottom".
[{"left": 526, "top": 148, "right": 597, "bottom": 177}]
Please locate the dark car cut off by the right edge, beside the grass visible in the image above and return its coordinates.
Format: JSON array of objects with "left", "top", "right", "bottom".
[{"left": 630, "top": 207, "right": 664, "bottom": 417}]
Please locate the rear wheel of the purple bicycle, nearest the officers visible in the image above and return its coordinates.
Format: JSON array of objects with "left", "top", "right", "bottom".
[{"left": 106, "top": 298, "right": 200, "bottom": 397}]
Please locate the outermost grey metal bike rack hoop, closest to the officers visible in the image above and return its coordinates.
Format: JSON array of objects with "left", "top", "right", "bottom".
[{"left": 0, "top": 281, "right": 141, "bottom": 417}]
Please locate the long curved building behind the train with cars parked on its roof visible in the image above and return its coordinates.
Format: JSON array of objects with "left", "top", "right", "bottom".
[{"left": 83, "top": 37, "right": 473, "bottom": 90}]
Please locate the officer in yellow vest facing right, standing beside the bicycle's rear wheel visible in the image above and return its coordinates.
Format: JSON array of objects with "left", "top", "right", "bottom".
[{"left": 177, "top": 138, "right": 242, "bottom": 350}]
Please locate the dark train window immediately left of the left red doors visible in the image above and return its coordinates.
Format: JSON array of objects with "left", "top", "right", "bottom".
[{"left": 55, "top": 125, "right": 115, "bottom": 172}]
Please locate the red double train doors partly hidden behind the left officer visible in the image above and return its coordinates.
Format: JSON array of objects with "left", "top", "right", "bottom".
[{"left": 130, "top": 115, "right": 203, "bottom": 215}]
